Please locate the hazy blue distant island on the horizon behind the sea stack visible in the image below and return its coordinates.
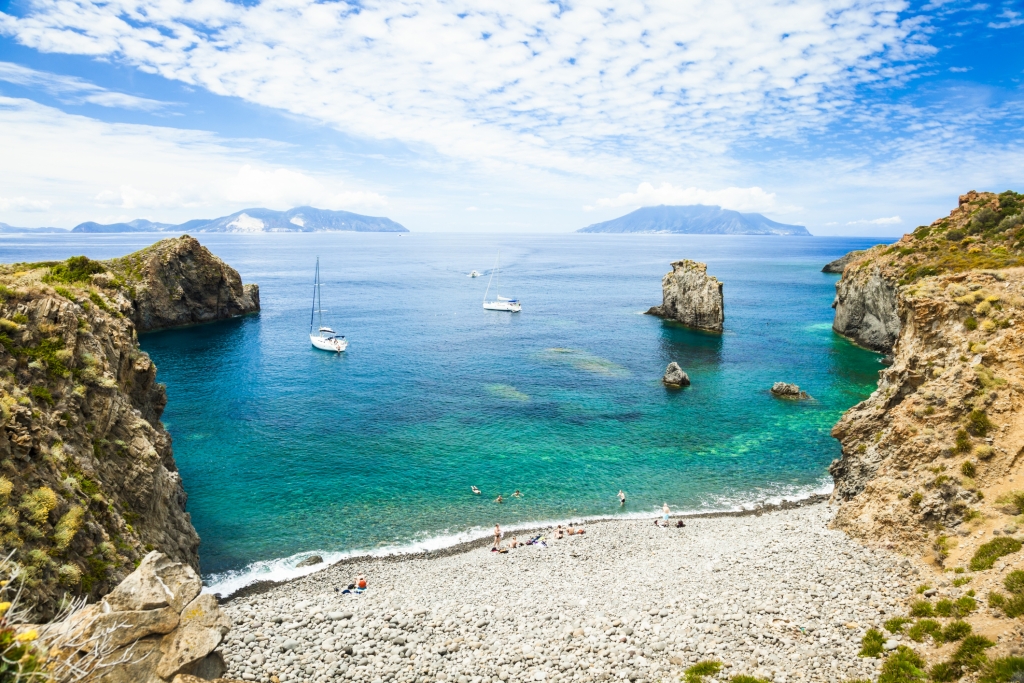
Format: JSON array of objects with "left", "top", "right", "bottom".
[{"left": 577, "top": 204, "right": 811, "bottom": 237}]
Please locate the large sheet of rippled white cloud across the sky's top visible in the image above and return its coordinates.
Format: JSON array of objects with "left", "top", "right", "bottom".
[{"left": 0, "top": 0, "right": 926, "bottom": 175}]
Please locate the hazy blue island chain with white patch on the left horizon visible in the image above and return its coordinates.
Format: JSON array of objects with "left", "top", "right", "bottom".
[{"left": 0, "top": 206, "right": 409, "bottom": 232}]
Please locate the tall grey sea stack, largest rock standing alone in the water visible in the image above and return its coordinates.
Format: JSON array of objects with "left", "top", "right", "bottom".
[{"left": 647, "top": 259, "right": 725, "bottom": 332}]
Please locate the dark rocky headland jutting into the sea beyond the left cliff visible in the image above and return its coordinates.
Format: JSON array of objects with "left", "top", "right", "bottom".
[{"left": 104, "top": 234, "right": 259, "bottom": 332}]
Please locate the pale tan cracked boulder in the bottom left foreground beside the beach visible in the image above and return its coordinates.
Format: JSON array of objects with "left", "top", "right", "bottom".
[{"left": 40, "top": 552, "right": 230, "bottom": 683}]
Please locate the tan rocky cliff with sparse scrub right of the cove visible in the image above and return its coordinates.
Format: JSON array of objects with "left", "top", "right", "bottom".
[{"left": 830, "top": 193, "right": 1024, "bottom": 559}]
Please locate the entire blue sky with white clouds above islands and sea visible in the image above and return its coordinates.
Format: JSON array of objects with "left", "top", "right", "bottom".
[{"left": 0, "top": 0, "right": 1024, "bottom": 236}]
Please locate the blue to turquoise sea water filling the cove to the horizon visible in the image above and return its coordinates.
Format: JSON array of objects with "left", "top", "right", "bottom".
[{"left": 0, "top": 233, "right": 880, "bottom": 589}]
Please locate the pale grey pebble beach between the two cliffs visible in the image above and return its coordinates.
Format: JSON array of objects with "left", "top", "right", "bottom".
[{"left": 222, "top": 503, "right": 915, "bottom": 683}]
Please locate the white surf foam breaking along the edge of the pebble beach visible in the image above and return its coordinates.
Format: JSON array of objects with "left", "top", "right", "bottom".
[{"left": 203, "top": 477, "right": 834, "bottom": 597}]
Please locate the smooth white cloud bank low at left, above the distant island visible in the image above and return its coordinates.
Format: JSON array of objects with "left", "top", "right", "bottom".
[{"left": 0, "top": 97, "right": 386, "bottom": 226}]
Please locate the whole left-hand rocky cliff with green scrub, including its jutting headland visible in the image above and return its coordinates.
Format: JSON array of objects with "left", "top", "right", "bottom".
[{"left": 0, "top": 238, "right": 258, "bottom": 616}]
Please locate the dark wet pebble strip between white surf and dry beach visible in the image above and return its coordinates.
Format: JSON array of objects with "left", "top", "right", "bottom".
[{"left": 220, "top": 494, "right": 830, "bottom": 604}]
